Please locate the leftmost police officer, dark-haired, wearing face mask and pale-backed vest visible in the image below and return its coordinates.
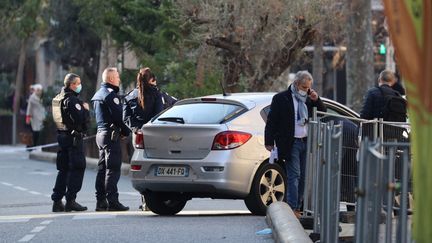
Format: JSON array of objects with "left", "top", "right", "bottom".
[{"left": 51, "top": 73, "right": 89, "bottom": 212}]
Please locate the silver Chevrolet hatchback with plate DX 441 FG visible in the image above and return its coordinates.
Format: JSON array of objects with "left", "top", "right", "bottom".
[{"left": 131, "top": 93, "right": 358, "bottom": 215}]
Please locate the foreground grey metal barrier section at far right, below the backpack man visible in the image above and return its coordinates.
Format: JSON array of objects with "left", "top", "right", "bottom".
[{"left": 355, "top": 138, "right": 411, "bottom": 243}]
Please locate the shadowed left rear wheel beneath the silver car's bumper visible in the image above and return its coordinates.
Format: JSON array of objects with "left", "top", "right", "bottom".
[{"left": 143, "top": 192, "right": 187, "bottom": 215}]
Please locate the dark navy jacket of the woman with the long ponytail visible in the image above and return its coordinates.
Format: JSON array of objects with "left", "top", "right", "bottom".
[{"left": 123, "top": 87, "right": 163, "bottom": 130}]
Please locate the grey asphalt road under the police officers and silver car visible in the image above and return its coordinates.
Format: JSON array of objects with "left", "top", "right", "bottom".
[{"left": 0, "top": 147, "right": 273, "bottom": 243}]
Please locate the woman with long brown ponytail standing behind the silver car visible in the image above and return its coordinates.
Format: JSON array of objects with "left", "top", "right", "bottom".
[{"left": 123, "top": 68, "right": 163, "bottom": 133}]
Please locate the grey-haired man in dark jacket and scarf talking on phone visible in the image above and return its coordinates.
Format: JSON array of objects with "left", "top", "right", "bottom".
[{"left": 265, "top": 71, "right": 326, "bottom": 216}]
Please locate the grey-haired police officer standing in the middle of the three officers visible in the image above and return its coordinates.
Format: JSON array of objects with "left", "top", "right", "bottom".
[{"left": 92, "top": 68, "right": 129, "bottom": 211}]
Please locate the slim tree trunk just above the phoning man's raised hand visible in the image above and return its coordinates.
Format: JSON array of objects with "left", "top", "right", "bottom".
[{"left": 312, "top": 33, "right": 324, "bottom": 95}]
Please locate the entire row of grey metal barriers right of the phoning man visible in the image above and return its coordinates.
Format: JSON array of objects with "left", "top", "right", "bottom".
[{"left": 303, "top": 108, "right": 411, "bottom": 242}]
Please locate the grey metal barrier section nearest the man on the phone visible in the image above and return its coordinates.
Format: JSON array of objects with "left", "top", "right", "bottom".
[{"left": 305, "top": 121, "right": 342, "bottom": 242}]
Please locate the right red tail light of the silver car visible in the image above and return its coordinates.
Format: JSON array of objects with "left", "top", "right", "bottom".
[{"left": 212, "top": 131, "right": 252, "bottom": 150}]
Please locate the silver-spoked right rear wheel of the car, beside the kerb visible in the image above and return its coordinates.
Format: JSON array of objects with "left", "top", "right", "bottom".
[{"left": 244, "top": 163, "right": 286, "bottom": 215}]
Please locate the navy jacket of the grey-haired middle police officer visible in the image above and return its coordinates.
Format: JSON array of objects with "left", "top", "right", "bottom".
[{"left": 91, "top": 83, "right": 129, "bottom": 136}]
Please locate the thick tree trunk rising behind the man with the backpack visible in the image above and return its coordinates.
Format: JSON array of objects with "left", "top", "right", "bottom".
[{"left": 346, "top": 0, "right": 374, "bottom": 111}]
